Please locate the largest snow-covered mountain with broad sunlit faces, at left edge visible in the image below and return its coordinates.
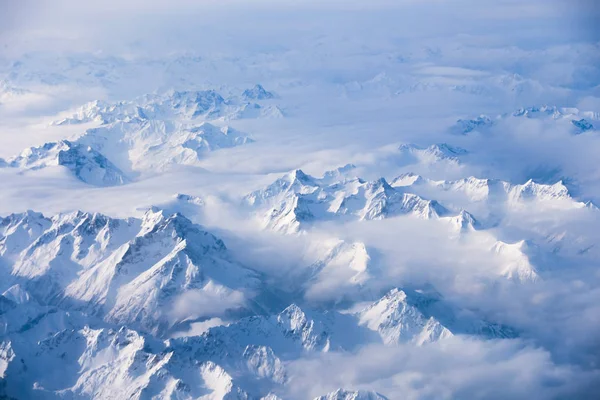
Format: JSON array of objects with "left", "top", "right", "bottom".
[{"left": 0, "top": 209, "right": 260, "bottom": 333}]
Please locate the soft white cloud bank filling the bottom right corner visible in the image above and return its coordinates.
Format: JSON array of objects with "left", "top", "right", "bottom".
[{"left": 288, "top": 337, "right": 599, "bottom": 400}]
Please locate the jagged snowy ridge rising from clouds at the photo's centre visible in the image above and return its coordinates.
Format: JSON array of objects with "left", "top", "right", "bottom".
[{"left": 245, "top": 170, "right": 450, "bottom": 233}]
